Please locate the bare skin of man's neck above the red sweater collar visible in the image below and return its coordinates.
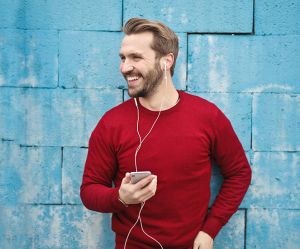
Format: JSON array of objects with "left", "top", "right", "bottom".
[{"left": 139, "top": 80, "right": 179, "bottom": 111}]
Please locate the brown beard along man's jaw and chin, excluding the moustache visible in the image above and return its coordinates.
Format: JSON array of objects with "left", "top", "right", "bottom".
[{"left": 128, "top": 62, "right": 163, "bottom": 98}]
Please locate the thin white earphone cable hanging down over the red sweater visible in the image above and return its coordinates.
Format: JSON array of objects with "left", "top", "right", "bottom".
[{"left": 124, "top": 63, "right": 168, "bottom": 249}]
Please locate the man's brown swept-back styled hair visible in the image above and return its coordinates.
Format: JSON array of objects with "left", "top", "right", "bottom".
[{"left": 123, "top": 17, "right": 179, "bottom": 76}]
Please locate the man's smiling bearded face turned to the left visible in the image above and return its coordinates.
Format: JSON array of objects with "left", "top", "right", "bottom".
[{"left": 120, "top": 32, "right": 163, "bottom": 97}]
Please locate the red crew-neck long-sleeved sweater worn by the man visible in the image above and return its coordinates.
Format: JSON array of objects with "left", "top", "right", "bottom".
[{"left": 80, "top": 91, "right": 251, "bottom": 249}]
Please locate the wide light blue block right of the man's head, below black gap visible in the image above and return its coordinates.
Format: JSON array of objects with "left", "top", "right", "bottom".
[{"left": 188, "top": 35, "right": 300, "bottom": 93}]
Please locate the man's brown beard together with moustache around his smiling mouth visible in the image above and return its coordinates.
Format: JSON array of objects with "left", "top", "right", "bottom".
[{"left": 124, "top": 62, "right": 163, "bottom": 98}]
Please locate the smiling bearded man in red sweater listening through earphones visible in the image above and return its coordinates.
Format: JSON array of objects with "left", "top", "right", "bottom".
[{"left": 81, "top": 18, "right": 251, "bottom": 249}]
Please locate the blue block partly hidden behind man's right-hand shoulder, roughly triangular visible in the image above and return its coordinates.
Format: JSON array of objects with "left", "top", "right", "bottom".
[{"left": 191, "top": 92, "right": 252, "bottom": 151}]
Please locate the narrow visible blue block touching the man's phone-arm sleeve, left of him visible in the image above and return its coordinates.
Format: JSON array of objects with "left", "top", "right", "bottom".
[{"left": 62, "top": 147, "right": 87, "bottom": 204}]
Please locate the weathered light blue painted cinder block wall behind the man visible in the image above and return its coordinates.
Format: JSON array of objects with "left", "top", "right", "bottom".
[{"left": 0, "top": 0, "right": 300, "bottom": 249}]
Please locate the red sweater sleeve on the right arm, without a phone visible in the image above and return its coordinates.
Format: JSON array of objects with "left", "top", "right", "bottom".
[{"left": 202, "top": 109, "right": 251, "bottom": 238}]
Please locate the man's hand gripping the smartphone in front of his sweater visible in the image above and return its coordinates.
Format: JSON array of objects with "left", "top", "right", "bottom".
[{"left": 119, "top": 173, "right": 157, "bottom": 204}]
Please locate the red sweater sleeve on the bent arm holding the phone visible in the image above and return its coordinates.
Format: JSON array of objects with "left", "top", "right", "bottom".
[{"left": 80, "top": 119, "right": 125, "bottom": 213}]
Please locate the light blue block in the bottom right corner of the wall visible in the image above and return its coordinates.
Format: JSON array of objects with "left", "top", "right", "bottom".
[{"left": 246, "top": 209, "right": 300, "bottom": 249}]
